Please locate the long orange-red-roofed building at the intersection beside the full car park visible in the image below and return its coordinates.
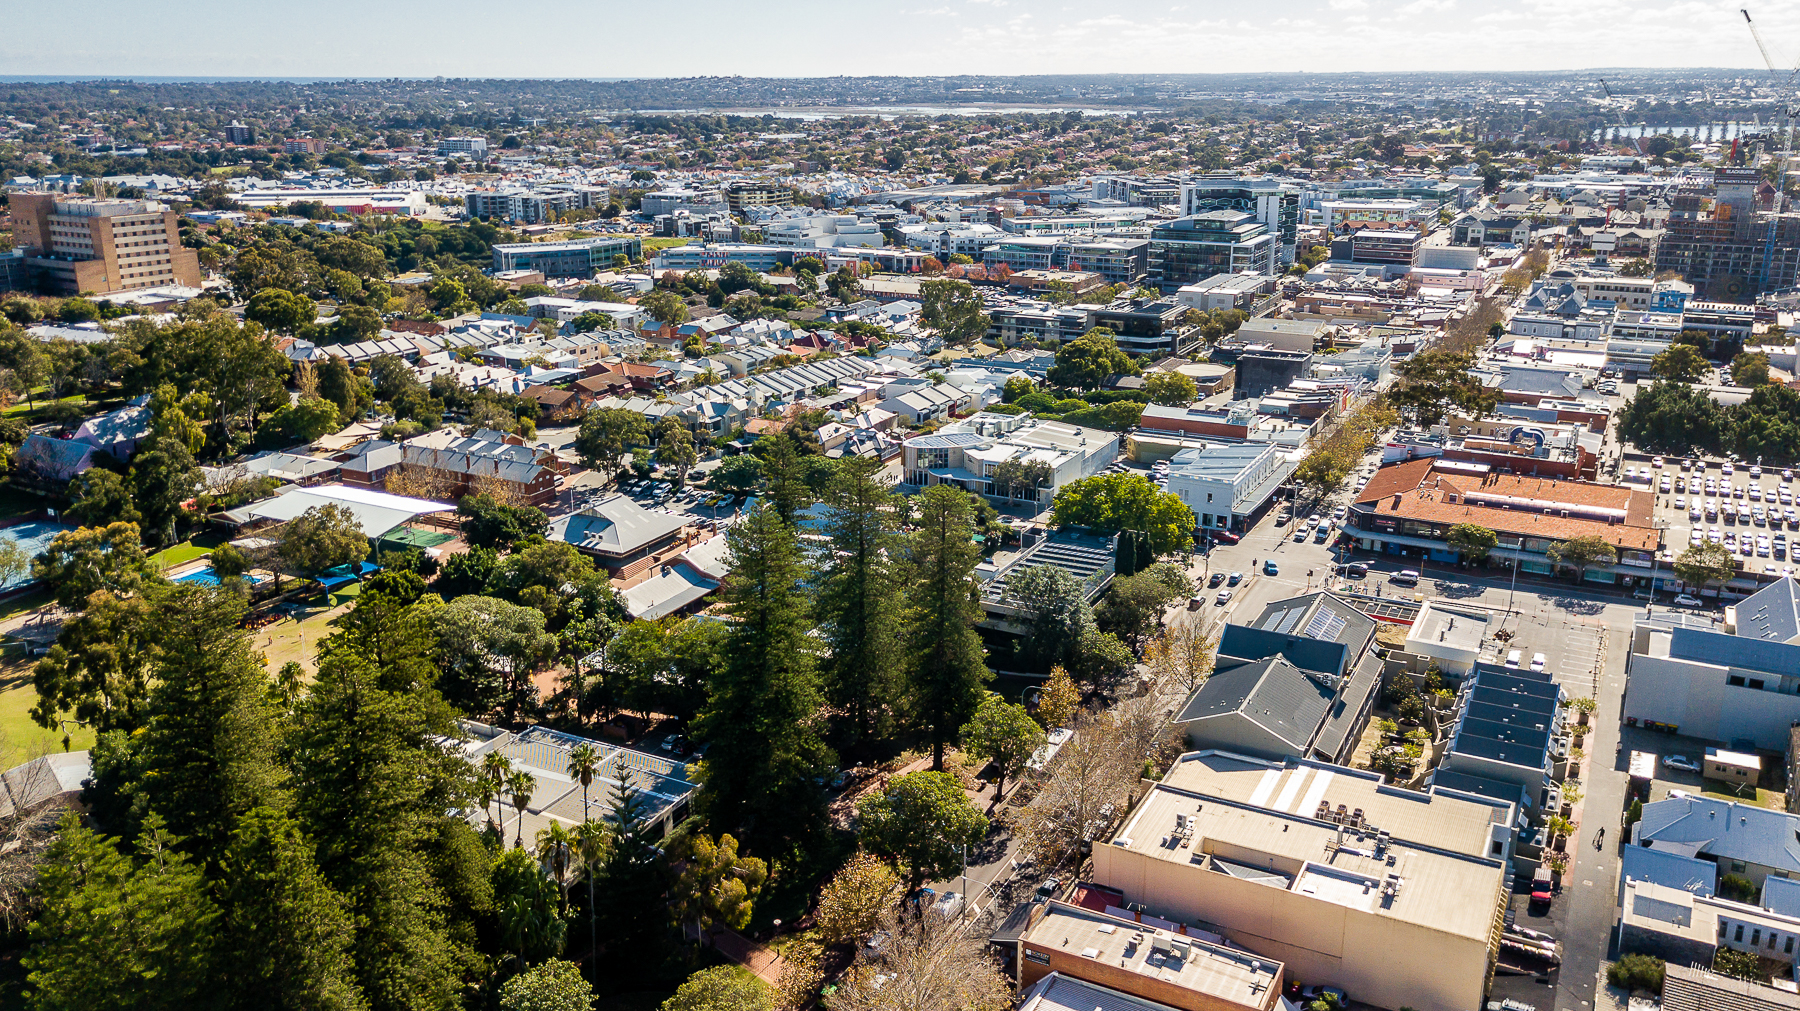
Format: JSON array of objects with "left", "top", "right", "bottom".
[{"left": 1345, "top": 455, "right": 1656, "bottom": 582}]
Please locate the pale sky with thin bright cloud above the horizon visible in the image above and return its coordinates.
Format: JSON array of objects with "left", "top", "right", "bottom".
[{"left": 10, "top": 0, "right": 1800, "bottom": 77}]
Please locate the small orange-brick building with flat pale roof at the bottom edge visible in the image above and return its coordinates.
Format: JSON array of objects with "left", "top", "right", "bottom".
[{"left": 992, "top": 899, "right": 1283, "bottom": 1011}]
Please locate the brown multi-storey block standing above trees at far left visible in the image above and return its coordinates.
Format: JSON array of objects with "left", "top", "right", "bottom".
[{"left": 11, "top": 192, "right": 203, "bottom": 295}]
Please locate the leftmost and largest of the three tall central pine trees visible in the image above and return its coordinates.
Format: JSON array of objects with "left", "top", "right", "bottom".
[{"left": 697, "top": 504, "right": 828, "bottom": 854}]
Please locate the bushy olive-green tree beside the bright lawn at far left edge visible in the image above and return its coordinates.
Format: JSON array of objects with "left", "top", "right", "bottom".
[{"left": 31, "top": 590, "right": 158, "bottom": 734}]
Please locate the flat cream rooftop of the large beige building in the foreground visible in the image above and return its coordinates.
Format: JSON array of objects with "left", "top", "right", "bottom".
[{"left": 1112, "top": 750, "right": 1512, "bottom": 939}]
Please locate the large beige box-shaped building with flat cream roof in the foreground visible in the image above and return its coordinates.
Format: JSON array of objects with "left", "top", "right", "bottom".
[{"left": 1093, "top": 750, "right": 1514, "bottom": 1011}]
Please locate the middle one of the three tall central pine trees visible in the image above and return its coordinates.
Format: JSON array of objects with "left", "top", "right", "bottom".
[{"left": 819, "top": 457, "right": 904, "bottom": 738}]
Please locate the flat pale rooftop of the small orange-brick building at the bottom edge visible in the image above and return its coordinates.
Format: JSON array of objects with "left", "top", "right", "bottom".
[{"left": 1021, "top": 901, "right": 1283, "bottom": 1007}]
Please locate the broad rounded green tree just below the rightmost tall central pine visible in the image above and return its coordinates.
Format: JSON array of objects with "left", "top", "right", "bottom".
[{"left": 857, "top": 770, "right": 988, "bottom": 890}]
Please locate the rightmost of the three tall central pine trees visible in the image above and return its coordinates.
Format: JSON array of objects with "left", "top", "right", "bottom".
[{"left": 905, "top": 484, "right": 994, "bottom": 770}]
